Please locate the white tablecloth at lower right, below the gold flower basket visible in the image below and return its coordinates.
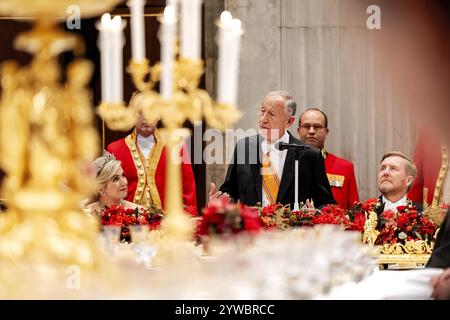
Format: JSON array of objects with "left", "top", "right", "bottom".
[{"left": 316, "top": 268, "right": 443, "bottom": 300}]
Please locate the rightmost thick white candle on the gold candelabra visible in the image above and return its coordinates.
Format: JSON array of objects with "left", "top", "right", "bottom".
[{"left": 217, "top": 11, "right": 242, "bottom": 105}]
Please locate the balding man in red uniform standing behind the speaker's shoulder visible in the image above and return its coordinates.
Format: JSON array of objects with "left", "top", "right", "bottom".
[{"left": 297, "top": 108, "right": 359, "bottom": 209}]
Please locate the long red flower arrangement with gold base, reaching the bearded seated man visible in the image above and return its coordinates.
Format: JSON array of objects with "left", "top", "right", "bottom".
[{"left": 258, "top": 199, "right": 445, "bottom": 264}]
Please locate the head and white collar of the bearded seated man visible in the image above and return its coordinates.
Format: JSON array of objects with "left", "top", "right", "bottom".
[{"left": 378, "top": 151, "right": 422, "bottom": 212}]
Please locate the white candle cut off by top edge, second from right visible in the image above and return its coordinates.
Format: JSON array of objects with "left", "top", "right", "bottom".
[{"left": 181, "top": 0, "right": 203, "bottom": 59}]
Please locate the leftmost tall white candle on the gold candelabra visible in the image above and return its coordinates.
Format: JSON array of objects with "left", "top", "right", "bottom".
[{"left": 97, "top": 13, "right": 112, "bottom": 102}]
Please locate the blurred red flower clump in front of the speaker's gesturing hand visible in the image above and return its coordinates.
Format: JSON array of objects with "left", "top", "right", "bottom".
[{"left": 197, "top": 199, "right": 261, "bottom": 237}]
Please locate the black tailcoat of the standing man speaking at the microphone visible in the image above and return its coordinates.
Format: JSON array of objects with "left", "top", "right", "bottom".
[{"left": 220, "top": 133, "right": 336, "bottom": 208}]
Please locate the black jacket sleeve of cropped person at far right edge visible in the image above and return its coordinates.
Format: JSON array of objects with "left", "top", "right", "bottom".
[{"left": 427, "top": 211, "right": 450, "bottom": 268}]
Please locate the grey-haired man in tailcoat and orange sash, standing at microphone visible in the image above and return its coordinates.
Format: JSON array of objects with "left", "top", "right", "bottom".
[{"left": 210, "top": 91, "right": 335, "bottom": 207}]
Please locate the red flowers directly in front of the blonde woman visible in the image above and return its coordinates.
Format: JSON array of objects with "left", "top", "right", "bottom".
[{"left": 101, "top": 206, "right": 164, "bottom": 242}]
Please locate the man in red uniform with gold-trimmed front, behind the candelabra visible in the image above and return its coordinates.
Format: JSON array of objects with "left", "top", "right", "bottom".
[{"left": 108, "top": 113, "right": 197, "bottom": 209}]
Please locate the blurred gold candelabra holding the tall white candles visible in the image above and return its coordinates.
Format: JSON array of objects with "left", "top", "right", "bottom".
[{"left": 98, "top": 59, "right": 241, "bottom": 241}]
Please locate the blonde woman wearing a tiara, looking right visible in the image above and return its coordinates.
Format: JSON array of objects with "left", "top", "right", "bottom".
[{"left": 86, "top": 151, "right": 138, "bottom": 217}]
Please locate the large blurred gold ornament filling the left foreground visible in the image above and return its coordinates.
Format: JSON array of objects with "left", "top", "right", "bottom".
[{"left": 0, "top": 0, "right": 122, "bottom": 299}]
